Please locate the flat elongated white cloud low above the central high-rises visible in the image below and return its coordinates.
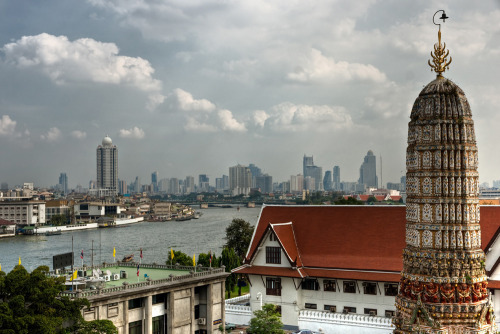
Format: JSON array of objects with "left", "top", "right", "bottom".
[{"left": 262, "top": 102, "right": 353, "bottom": 132}]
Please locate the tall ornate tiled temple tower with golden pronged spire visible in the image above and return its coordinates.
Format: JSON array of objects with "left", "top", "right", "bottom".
[{"left": 393, "top": 11, "right": 496, "bottom": 334}]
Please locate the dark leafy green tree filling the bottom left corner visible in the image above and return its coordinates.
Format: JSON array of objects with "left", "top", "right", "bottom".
[{"left": 0, "top": 265, "right": 116, "bottom": 334}]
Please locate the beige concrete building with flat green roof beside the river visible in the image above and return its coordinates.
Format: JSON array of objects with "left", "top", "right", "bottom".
[{"left": 60, "top": 263, "right": 228, "bottom": 334}]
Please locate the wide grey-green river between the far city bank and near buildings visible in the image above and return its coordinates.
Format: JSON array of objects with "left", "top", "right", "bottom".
[{"left": 0, "top": 207, "right": 260, "bottom": 272}]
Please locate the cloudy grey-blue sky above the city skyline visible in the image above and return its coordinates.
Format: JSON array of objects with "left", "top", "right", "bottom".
[{"left": 0, "top": 0, "right": 500, "bottom": 187}]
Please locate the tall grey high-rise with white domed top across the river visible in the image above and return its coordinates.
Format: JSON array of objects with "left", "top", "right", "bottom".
[{"left": 97, "top": 136, "right": 118, "bottom": 193}]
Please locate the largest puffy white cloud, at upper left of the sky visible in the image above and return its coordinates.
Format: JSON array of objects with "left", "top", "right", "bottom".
[{"left": 2, "top": 33, "right": 161, "bottom": 106}]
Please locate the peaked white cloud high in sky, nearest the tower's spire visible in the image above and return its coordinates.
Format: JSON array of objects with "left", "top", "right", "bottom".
[{"left": 287, "top": 49, "right": 386, "bottom": 83}]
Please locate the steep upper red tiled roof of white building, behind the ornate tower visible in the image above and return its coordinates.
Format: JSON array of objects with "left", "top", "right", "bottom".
[{"left": 242, "top": 205, "right": 500, "bottom": 275}]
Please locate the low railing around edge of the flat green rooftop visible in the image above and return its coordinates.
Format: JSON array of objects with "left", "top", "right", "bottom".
[{"left": 61, "top": 263, "right": 225, "bottom": 298}]
